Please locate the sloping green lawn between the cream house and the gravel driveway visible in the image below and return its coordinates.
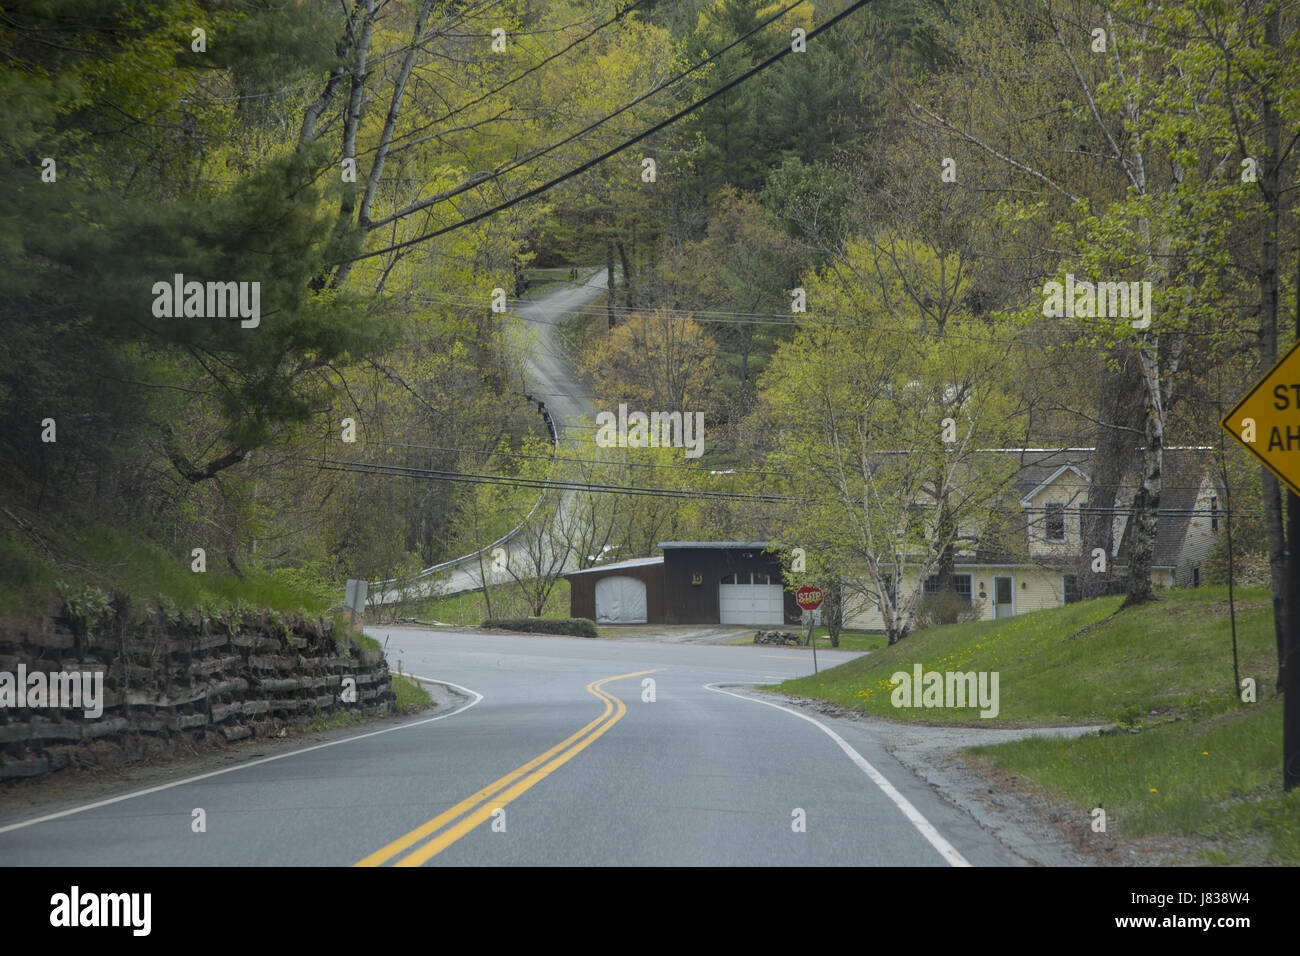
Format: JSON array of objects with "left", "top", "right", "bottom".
[{"left": 779, "top": 588, "right": 1277, "bottom": 726}]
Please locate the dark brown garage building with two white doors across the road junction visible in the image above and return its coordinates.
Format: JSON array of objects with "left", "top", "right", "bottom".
[{"left": 564, "top": 541, "right": 800, "bottom": 624}]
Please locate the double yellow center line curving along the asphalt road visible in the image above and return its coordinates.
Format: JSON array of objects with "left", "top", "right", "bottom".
[{"left": 355, "top": 670, "right": 654, "bottom": 866}]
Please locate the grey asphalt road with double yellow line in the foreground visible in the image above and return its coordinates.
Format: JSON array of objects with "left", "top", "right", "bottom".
[{"left": 0, "top": 628, "right": 1019, "bottom": 866}]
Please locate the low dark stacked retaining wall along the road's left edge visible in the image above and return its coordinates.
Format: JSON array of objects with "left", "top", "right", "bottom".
[{"left": 0, "top": 613, "right": 394, "bottom": 780}]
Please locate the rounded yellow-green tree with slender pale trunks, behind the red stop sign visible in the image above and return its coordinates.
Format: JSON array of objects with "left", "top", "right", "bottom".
[{"left": 753, "top": 242, "right": 1022, "bottom": 644}]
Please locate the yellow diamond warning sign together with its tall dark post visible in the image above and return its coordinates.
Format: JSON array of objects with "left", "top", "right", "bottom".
[{"left": 1219, "top": 341, "right": 1300, "bottom": 791}]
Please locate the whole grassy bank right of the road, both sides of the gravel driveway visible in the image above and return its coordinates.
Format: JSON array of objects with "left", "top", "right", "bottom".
[{"left": 779, "top": 588, "right": 1300, "bottom": 864}]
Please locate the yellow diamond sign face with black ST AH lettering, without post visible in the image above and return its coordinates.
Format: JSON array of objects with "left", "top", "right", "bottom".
[{"left": 1219, "top": 342, "right": 1300, "bottom": 494}]
